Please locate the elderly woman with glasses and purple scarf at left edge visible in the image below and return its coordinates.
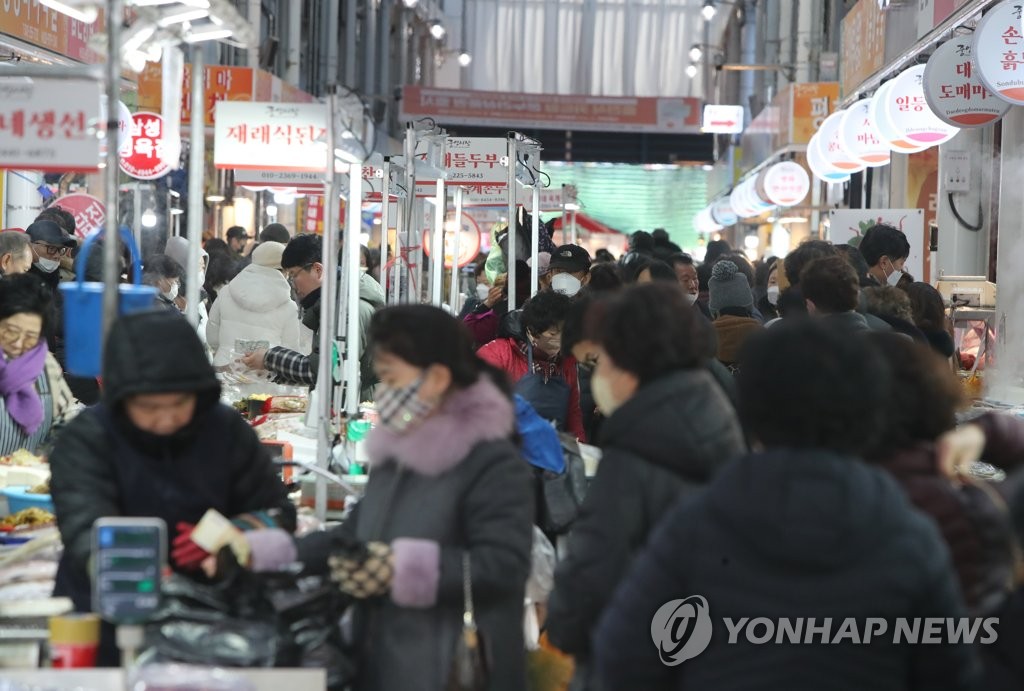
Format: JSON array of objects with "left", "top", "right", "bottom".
[{"left": 0, "top": 274, "right": 78, "bottom": 456}]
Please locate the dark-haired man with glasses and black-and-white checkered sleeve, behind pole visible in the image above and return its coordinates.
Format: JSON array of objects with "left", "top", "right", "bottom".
[{"left": 242, "top": 234, "right": 324, "bottom": 387}]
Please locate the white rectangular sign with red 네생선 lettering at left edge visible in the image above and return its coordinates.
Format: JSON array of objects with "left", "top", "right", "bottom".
[{"left": 0, "top": 77, "right": 102, "bottom": 172}]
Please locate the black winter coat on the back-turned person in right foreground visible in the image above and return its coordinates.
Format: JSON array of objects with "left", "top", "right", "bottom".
[{"left": 594, "top": 449, "right": 980, "bottom": 691}]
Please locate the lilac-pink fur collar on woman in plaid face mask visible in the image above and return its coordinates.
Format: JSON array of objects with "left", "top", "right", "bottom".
[{"left": 367, "top": 375, "right": 515, "bottom": 475}]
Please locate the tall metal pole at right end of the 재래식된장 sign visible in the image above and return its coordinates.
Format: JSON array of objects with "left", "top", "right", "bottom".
[{"left": 314, "top": 91, "right": 338, "bottom": 520}]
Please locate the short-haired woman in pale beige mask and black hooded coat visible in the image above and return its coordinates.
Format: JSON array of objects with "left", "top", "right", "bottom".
[{"left": 547, "top": 283, "right": 743, "bottom": 689}]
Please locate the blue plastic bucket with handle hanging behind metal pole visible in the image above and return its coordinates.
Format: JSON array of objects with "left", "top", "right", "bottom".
[{"left": 60, "top": 226, "right": 157, "bottom": 377}]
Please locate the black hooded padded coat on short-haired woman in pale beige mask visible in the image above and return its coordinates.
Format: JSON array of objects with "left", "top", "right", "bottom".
[{"left": 547, "top": 370, "right": 744, "bottom": 659}]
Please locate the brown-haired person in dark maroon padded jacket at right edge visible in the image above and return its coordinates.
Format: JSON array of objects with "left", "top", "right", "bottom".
[{"left": 866, "top": 331, "right": 1024, "bottom": 616}]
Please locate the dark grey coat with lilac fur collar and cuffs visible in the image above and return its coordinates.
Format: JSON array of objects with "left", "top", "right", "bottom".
[{"left": 298, "top": 378, "right": 534, "bottom": 691}]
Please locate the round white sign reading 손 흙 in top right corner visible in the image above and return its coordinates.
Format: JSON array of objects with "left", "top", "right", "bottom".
[{"left": 972, "top": 1, "right": 1024, "bottom": 105}]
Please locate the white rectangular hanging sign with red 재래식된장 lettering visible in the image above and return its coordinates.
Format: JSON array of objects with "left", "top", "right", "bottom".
[{"left": 213, "top": 100, "right": 328, "bottom": 173}]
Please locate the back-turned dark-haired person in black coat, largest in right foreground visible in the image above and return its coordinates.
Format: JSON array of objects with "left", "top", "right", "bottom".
[{"left": 594, "top": 319, "right": 979, "bottom": 691}]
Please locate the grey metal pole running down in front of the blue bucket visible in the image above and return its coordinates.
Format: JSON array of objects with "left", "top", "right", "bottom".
[{"left": 101, "top": 0, "right": 123, "bottom": 349}]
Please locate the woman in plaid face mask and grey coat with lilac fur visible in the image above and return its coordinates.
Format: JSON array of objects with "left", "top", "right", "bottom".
[{"left": 242, "top": 305, "right": 534, "bottom": 691}]
